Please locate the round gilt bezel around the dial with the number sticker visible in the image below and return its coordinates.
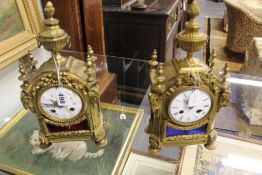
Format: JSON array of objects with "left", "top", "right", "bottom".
[{"left": 36, "top": 84, "right": 86, "bottom": 125}]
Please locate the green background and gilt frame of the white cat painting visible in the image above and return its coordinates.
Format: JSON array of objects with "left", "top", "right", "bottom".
[{"left": 0, "top": 104, "right": 143, "bottom": 175}]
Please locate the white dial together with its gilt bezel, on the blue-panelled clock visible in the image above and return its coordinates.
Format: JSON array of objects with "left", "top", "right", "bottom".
[{"left": 167, "top": 86, "right": 214, "bottom": 126}]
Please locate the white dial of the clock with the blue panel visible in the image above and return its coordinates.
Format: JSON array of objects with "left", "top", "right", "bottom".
[{"left": 169, "top": 89, "right": 211, "bottom": 123}]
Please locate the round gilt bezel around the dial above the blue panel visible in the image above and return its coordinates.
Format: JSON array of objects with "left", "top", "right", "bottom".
[{"left": 167, "top": 86, "right": 214, "bottom": 126}]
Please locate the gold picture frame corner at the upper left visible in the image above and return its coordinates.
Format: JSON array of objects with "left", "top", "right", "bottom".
[{"left": 0, "top": 0, "right": 43, "bottom": 69}]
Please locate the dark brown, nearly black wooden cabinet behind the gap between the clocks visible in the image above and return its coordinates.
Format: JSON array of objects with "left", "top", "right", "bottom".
[{"left": 103, "top": 0, "right": 187, "bottom": 104}]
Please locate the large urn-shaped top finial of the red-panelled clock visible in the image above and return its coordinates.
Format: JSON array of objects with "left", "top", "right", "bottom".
[{"left": 37, "top": 1, "right": 70, "bottom": 62}]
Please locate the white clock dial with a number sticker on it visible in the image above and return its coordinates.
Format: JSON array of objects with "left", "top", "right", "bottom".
[{"left": 40, "top": 87, "right": 83, "bottom": 120}]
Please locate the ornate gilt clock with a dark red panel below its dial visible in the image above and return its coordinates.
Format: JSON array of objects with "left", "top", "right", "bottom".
[{"left": 19, "top": 2, "right": 107, "bottom": 147}]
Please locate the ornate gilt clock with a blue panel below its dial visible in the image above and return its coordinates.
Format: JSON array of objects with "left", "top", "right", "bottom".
[{"left": 145, "top": 0, "right": 231, "bottom": 153}]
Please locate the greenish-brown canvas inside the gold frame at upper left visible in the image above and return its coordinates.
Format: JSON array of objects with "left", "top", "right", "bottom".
[{"left": 0, "top": 0, "right": 24, "bottom": 41}]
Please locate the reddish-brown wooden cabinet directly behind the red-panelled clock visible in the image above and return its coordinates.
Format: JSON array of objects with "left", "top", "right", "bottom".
[{"left": 42, "top": 0, "right": 118, "bottom": 103}]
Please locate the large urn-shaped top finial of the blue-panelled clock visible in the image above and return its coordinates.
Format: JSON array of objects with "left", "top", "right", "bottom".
[{"left": 177, "top": 0, "right": 207, "bottom": 62}]
